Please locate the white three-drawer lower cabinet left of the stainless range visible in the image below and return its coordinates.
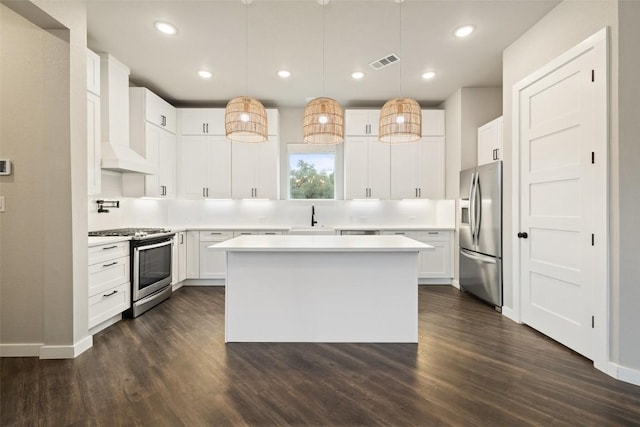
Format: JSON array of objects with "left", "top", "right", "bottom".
[{"left": 87, "top": 241, "right": 131, "bottom": 329}]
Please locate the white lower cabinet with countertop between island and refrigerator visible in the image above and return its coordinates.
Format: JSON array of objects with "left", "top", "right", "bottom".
[{"left": 383, "top": 230, "right": 453, "bottom": 284}]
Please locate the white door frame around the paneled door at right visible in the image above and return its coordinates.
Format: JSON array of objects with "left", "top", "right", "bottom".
[{"left": 506, "top": 27, "right": 611, "bottom": 373}]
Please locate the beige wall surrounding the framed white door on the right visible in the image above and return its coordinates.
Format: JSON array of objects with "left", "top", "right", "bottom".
[{"left": 503, "top": 0, "right": 640, "bottom": 369}]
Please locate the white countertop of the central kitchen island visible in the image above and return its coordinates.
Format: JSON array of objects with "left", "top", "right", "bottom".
[{"left": 208, "top": 235, "right": 434, "bottom": 252}]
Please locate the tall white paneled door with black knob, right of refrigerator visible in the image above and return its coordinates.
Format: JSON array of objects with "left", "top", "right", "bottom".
[{"left": 518, "top": 36, "right": 607, "bottom": 359}]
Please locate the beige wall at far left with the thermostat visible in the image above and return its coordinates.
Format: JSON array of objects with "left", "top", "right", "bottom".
[{"left": 0, "top": 1, "right": 88, "bottom": 357}]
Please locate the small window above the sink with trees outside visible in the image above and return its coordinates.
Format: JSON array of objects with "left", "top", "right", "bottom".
[{"left": 287, "top": 144, "right": 336, "bottom": 199}]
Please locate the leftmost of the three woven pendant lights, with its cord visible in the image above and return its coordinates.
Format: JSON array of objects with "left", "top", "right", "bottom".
[{"left": 224, "top": 0, "right": 269, "bottom": 142}]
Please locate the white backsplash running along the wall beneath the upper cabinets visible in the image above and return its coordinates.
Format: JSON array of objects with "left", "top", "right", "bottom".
[{"left": 88, "top": 172, "right": 455, "bottom": 230}]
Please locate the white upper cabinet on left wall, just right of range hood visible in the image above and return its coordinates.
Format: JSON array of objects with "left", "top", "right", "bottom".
[{"left": 122, "top": 87, "right": 176, "bottom": 197}]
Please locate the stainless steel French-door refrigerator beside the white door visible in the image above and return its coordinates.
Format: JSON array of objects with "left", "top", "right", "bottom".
[{"left": 459, "top": 162, "right": 502, "bottom": 310}]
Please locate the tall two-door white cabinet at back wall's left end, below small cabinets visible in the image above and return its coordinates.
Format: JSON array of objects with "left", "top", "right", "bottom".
[{"left": 179, "top": 135, "right": 231, "bottom": 199}]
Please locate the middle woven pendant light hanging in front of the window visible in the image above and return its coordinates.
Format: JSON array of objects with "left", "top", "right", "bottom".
[{"left": 302, "top": 0, "right": 344, "bottom": 145}]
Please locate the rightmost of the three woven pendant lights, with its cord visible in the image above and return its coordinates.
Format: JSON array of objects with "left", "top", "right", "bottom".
[{"left": 378, "top": 1, "right": 422, "bottom": 143}]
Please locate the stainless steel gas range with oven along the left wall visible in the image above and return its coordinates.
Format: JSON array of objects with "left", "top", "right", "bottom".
[{"left": 89, "top": 228, "right": 175, "bottom": 317}]
